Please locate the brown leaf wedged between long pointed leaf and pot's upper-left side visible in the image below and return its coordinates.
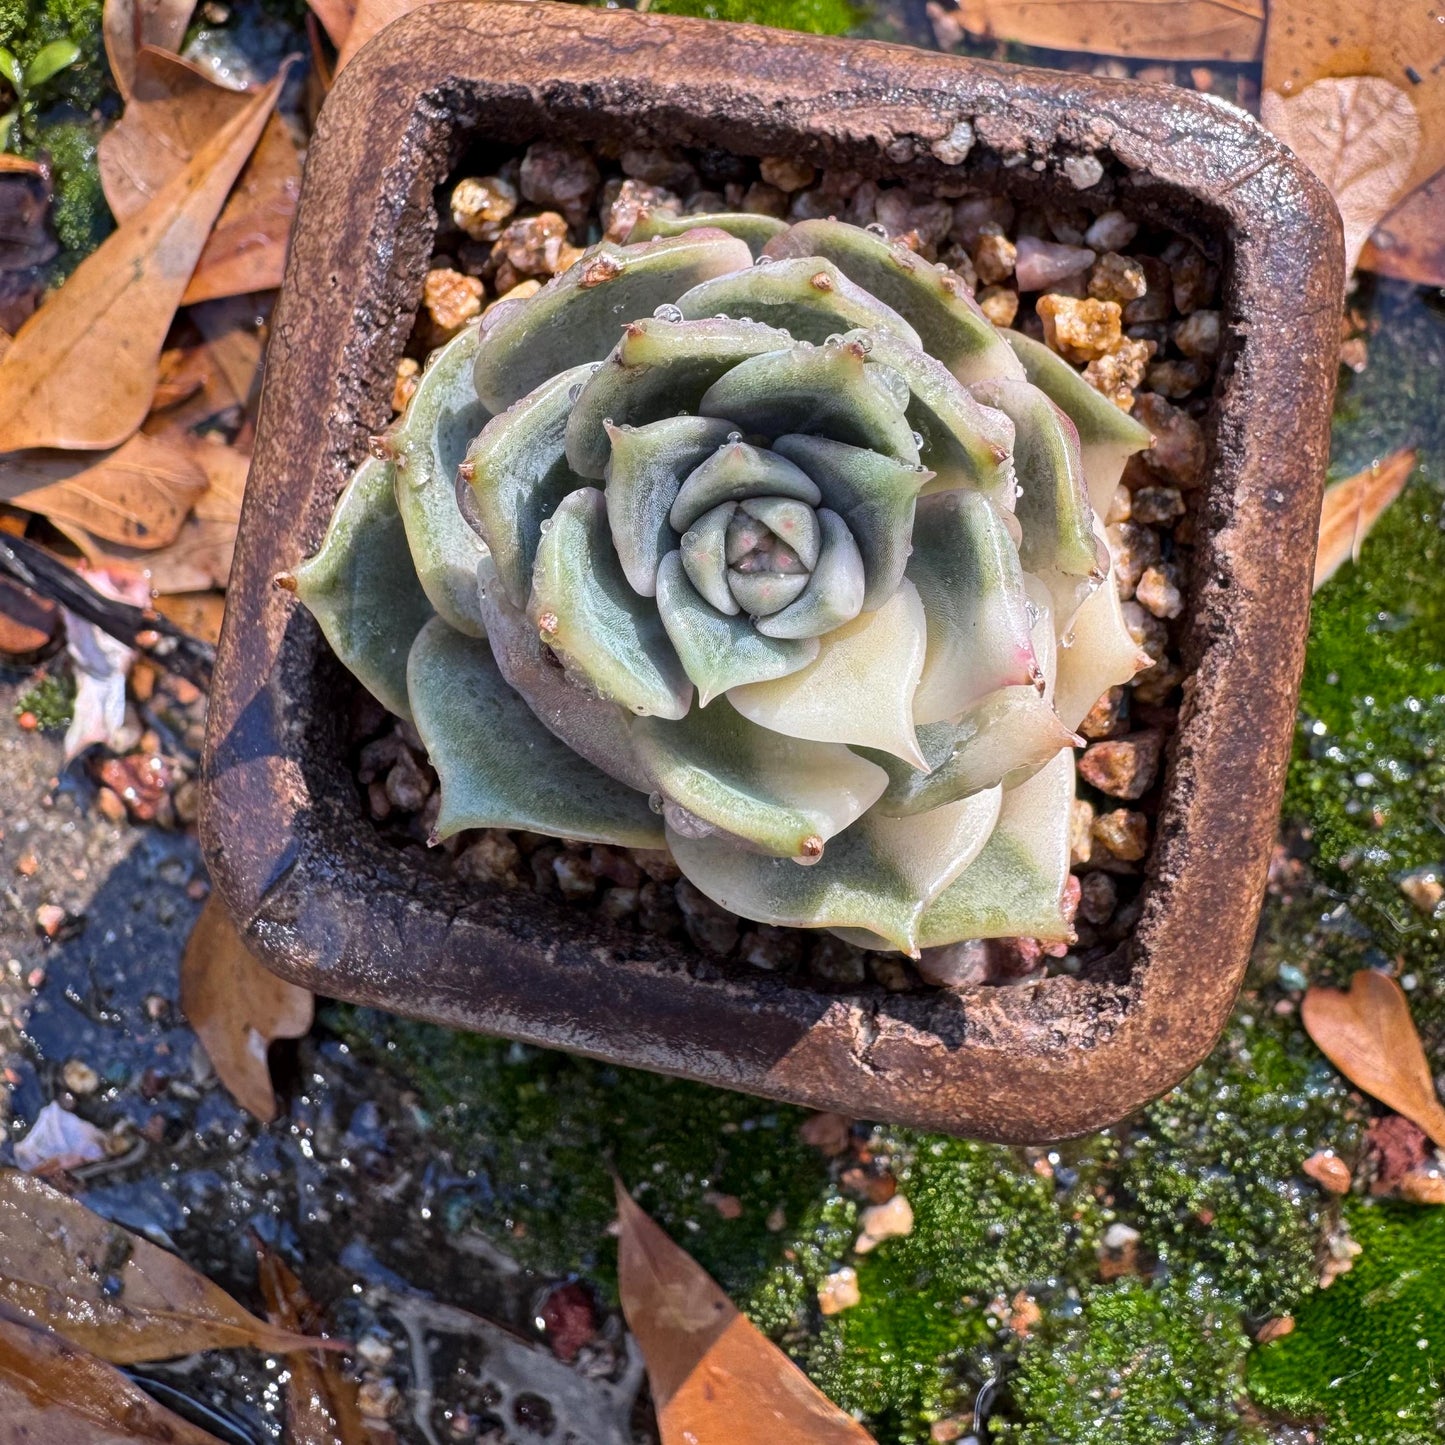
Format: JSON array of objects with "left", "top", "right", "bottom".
[{"left": 181, "top": 114, "right": 301, "bottom": 306}]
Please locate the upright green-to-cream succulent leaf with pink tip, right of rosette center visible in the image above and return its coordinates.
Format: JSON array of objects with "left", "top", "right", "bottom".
[{"left": 907, "top": 491, "right": 1062, "bottom": 722}]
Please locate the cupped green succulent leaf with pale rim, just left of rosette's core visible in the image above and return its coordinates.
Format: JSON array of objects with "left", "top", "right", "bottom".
[{"left": 527, "top": 487, "right": 692, "bottom": 718}]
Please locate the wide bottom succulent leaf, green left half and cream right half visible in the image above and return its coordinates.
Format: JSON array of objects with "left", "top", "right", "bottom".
[{"left": 668, "top": 790, "right": 1000, "bottom": 957}]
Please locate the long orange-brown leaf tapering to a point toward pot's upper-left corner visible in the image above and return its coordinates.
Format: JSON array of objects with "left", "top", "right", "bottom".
[{"left": 0, "top": 69, "right": 285, "bottom": 451}]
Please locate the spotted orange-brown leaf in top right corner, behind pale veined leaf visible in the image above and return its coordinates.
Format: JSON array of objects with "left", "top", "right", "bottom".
[{"left": 1263, "top": 0, "right": 1445, "bottom": 195}]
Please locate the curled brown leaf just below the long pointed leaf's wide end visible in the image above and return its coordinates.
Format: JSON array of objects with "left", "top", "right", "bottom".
[{"left": 0, "top": 432, "right": 208, "bottom": 551}]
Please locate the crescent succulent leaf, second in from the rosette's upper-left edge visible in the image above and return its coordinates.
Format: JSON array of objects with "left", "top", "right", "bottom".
[{"left": 461, "top": 366, "right": 591, "bottom": 607}]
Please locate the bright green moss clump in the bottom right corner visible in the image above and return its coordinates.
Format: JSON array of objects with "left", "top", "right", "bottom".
[{"left": 1248, "top": 1199, "right": 1445, "bottom": 1445}]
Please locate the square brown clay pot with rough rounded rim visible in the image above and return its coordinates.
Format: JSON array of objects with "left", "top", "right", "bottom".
[{"left": 201, "top": 3, "right": 1344, "bottom": 1140}]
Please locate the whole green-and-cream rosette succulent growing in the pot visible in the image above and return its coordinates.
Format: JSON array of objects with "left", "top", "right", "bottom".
[{"left": 296, "top": 215, "right": 1147, "bottom": 955}]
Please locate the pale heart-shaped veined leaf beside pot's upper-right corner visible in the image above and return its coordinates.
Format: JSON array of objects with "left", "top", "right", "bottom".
[{"left": 1260, "top": 75, "right": 1420, "bottom": 270}]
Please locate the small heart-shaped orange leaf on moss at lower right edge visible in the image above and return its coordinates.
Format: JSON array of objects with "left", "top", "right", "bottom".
[{"left": 1301, "top": 968, "right": 1445, "bottom": 1149}]
